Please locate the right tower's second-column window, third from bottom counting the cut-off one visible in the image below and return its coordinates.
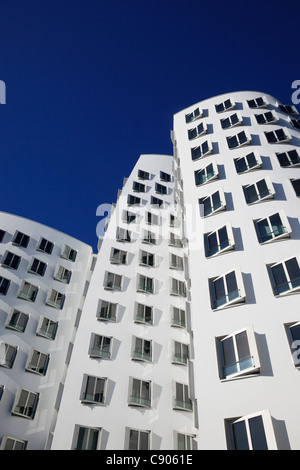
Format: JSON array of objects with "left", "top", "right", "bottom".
[{"left": 254, "top": 211, "right": 292, "bottom": 243}]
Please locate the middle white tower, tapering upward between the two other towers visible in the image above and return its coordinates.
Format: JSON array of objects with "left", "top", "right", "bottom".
[{"left": 52, "top": 155, "right": 196, "bottom": 450}]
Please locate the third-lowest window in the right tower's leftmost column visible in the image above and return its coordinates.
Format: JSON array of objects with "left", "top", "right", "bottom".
[{"left": 209, "top": 269, "right": 246, "bottom": 310}]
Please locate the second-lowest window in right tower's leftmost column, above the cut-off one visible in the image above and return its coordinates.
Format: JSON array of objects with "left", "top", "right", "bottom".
[{"left": 217, "top": 327, "right": 260, "bottom": 379}]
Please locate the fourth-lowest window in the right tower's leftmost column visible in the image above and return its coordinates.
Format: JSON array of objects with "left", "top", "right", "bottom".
[{"left": 204, "top": 224, "right": 234, "bottom": 258}]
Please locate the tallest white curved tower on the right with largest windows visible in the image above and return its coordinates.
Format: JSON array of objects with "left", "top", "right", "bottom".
[{"left": 172, "top": 92, "right": 300, "bottom": 449}]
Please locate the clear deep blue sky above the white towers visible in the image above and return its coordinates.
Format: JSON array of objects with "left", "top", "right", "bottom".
[{"left": 0, "top": 0, "right": 300, "bottom": 249}]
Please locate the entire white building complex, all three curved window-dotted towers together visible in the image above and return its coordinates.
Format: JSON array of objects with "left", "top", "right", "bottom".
[{"left": 0, "top": 92, "right": 300, "bottom": 450}]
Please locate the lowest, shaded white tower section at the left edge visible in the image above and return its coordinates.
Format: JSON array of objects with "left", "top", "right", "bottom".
[{"left": 0, "top": 212, "right": 93, "bottom": 450}]
